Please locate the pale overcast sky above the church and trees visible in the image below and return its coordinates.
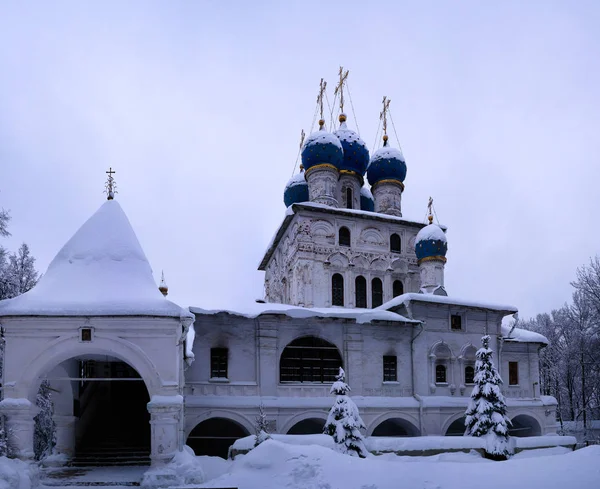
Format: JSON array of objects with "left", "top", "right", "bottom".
[{"left": 0, "top": 1, "right": 600, "bottom": 316}]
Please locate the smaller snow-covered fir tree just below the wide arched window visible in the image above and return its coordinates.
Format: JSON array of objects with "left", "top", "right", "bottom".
[{"left": 323, "top": 367, "right": 367, "bottom": 458}]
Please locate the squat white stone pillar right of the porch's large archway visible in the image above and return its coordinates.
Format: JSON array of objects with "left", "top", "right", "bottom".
[{"left": 147, "top": 394, "right": 183, "bottom": 466}]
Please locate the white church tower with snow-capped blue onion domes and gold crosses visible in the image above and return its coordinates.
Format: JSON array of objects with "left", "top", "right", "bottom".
[{"left": 259, "top": 72, "right": 447, "bottom": 308}]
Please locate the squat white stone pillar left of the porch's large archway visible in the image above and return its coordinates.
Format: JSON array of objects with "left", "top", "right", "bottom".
[{"left": 0, "top": 397, "right": 38, "bottom": 460}]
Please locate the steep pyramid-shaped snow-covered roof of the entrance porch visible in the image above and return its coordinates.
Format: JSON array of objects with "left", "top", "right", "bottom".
[{"left": 0, "top": 200, "right": 190, "bottom": 317}]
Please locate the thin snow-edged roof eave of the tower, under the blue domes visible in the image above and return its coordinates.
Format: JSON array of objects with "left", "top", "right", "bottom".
[{"left": 258, "top": 202, "right": 446, "bottom": 270}]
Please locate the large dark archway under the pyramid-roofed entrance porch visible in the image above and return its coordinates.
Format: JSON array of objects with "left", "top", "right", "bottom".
[{"left": 41, "top": 354, "right": 150, "bottom": 466}]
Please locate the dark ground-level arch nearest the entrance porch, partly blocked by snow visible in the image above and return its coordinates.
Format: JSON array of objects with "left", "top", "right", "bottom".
[{"left": 186, "top": 418, "right": 250, "bottom": 459}]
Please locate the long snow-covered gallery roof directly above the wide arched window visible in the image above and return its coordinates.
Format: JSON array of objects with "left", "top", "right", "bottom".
[{"left": 190, "top": 302, "right": 420, "bottom": 324}]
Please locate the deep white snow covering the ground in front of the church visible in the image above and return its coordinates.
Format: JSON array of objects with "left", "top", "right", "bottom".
[{"left": 5, "top": 440, "right": 600, "bottom": 489}]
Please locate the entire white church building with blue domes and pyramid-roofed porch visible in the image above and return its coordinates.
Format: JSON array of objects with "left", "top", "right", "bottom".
[{"left": 0, "top": 80, "right": 556, "bottom": 465}]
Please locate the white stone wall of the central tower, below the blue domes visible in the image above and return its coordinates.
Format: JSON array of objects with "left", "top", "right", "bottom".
[{"left": 265, "top": 210, "right": 422, "bottom": 307}]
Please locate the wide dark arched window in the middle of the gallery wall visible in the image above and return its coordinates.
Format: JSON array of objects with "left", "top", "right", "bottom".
[{"left": 279, "top": 336, "right": 343, "bottom": 383}]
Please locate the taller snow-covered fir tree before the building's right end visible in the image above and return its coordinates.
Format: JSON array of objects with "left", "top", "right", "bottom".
[{"left": 465, "top": 335, "right": 510, "bottom": 460}]
